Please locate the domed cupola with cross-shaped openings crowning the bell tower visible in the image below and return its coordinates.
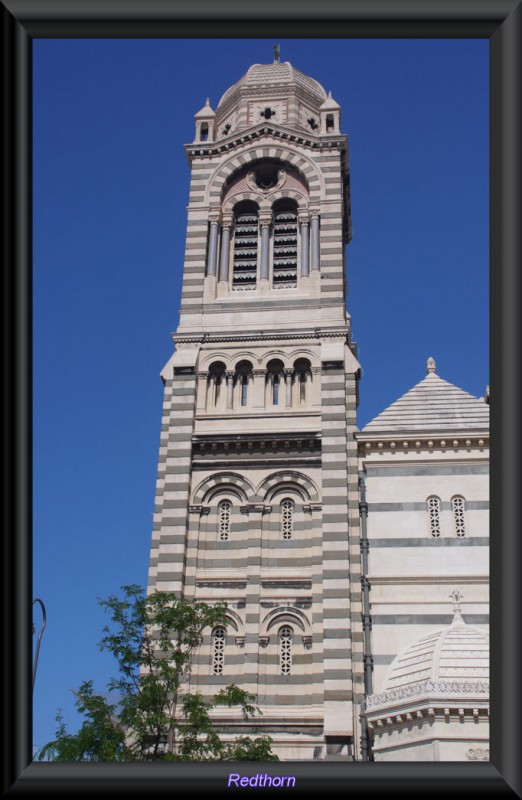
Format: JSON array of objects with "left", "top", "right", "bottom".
[{"left": 212, "top": 51, "right": 328, "bottom": 139}]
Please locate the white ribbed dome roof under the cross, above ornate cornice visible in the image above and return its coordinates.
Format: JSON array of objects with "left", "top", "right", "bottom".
[{"left": 382, "top": 607, "right": 489, "bottom": 692}]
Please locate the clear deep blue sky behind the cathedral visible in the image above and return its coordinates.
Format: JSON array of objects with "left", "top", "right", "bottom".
[{"left": 33, "top": 38, "right": 489, "bottom": 746}]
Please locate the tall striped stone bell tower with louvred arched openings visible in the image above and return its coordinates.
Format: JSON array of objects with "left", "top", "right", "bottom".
[{"left": 149, "top": 57, "right": 364, "bottom": 760}]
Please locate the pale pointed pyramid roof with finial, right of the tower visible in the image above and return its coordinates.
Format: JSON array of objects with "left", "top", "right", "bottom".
[{"left": 361, "top": 358, "right": 489, "bottom": 433}]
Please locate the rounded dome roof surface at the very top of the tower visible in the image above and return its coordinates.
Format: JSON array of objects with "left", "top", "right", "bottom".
[{"left": 217, "top": 61, "right": 327, "bottom": 109}]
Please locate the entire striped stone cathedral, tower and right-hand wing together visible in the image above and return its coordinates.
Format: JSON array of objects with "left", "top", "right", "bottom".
[{"left": 149, "top": 57, "right": 489, "bottom": 761}]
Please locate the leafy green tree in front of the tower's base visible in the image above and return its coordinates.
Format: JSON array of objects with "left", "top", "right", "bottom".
[{"left": 36, "top": 585, "right": 278, "bottom": 761}]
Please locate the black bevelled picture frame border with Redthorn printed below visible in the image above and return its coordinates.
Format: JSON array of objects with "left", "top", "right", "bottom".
[{"left": 1, "top": 0, "right": 522, "bottom": 797}]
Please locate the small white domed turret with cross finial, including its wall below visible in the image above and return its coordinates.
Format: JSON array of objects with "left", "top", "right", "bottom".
[{"left": 366, "top": 590, "right": 489, "bottom": 761}]
